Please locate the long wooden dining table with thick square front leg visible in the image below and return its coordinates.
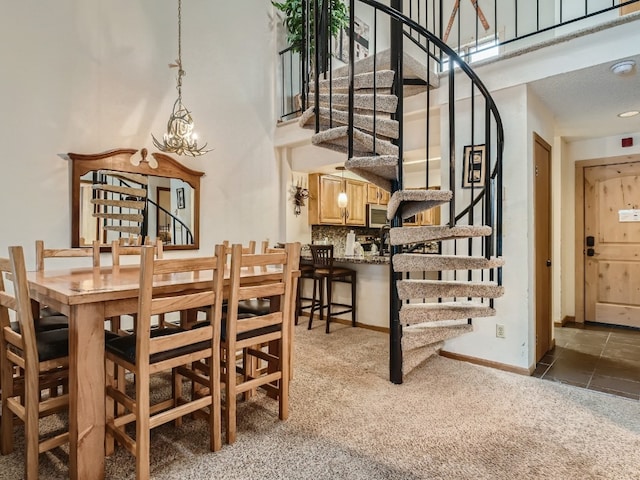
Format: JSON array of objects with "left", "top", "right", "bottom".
[{"left": 28, "top": 265, "right": 299, "bottom": 480}]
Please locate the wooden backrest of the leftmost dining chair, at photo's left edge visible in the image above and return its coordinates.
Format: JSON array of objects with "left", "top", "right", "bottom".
[{"left": 0, "top": 247, "right": 39, "bottom": 378}]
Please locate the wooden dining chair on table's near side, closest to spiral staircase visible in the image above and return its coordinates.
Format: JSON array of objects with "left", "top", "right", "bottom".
[{"left": 221, "top": 243, "right": 300, "bottom": 443}]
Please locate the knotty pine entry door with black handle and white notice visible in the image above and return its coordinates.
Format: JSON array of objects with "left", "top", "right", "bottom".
[{"left": 584, "top": 162, "right": 640, "bottom": 327}]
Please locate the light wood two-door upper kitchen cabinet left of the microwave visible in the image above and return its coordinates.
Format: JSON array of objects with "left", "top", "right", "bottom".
[{"left": 309, "top": 173, "right": 367, "bottom": 226}]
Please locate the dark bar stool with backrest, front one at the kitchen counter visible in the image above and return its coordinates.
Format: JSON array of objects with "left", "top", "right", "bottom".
[{"left": 307, "top": 245, "right": 356, "bottom": 333}]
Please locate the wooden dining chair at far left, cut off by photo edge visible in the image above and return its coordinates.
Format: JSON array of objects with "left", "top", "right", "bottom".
[{"left": 0, "top": 247, "right": 69, "bottom": 480}]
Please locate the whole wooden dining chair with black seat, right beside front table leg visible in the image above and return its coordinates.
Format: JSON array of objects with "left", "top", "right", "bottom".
[{"left": 105, "top": 245, "right": 225, "bottom": 479}]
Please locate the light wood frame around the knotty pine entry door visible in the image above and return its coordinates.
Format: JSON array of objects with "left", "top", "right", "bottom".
[{"left": 574, "top": 154, "right": 640, "bottom": 323}]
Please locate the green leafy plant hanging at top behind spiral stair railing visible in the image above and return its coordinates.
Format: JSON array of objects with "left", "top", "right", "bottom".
[{"left": 271, "top": 0, "right": 349, "bottom": 52}]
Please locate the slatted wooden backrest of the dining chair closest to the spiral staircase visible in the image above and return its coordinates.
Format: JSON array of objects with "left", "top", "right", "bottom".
[{"left": 225, "top": 242, "right": 300, "bottom": 343}]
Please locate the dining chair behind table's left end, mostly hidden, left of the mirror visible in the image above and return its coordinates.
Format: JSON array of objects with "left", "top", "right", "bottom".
[{"left": 32, "top": 240, "right": 100, "bottom": 330}]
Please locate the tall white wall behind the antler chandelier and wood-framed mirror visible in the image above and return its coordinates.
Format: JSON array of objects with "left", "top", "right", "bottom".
[{"left": 0, "top": 0, "right": 284, "bottom": 267}]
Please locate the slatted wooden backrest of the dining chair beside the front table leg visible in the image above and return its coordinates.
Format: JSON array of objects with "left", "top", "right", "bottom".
[{"left": 136, "top": 245, "right": 226, "bottom": 362}]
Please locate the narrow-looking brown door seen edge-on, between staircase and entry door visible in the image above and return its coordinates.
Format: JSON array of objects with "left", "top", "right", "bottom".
[{"left": 533, "top": 135, "right": 552, "bottom": 362}]
